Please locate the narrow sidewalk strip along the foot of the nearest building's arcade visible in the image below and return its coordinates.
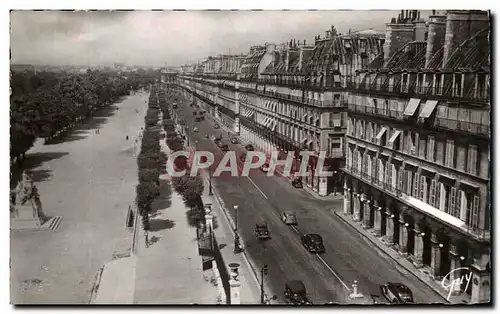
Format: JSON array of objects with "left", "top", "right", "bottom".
[{"left": 332, "top": 207, "right": 468, "bottom": 304}]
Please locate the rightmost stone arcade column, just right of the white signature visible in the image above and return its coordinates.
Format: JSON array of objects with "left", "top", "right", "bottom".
[{"left": 470, "top": 252, "right": 491, "bottom": 303}]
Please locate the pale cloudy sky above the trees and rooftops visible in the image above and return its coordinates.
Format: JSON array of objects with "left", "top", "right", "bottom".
[{"left": 10, "top": 11, "right": 429, "bottom": 66}]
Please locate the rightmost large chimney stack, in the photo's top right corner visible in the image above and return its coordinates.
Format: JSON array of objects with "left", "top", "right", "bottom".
[{"left": 443, "top": 10, "right": 490, "bottom": 67}]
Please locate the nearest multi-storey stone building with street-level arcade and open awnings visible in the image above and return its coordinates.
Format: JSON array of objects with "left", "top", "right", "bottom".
[{"left": 344, "top": 11, "right": 491, "bottom": 302}]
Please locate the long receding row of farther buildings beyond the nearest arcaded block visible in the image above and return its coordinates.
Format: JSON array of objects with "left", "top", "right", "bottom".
[{"left": 175, "top": 27, "right": 384, "bottom": 195}]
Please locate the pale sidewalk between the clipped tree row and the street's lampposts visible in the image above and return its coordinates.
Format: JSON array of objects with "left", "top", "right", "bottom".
[{"left": 134, "top": 118, "right": 218, "bottom": 304}]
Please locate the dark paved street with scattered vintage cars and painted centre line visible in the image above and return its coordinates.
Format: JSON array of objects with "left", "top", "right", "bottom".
[{"left": 172, "top": 92, "right": 444, "bottom": 304}]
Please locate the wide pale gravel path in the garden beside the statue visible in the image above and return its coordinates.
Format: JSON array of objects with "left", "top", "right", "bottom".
[{"left": 11, "top": 92, "right": 149, "bottom": 304}]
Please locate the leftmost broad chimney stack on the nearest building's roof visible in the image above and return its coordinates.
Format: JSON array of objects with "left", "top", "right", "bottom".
[{"left": 384, "top": 11, "right": 414, "bottom": 66}]
